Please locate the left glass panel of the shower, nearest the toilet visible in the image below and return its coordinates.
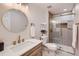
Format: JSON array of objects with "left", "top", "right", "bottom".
[{"left": 50, "top": 21, "right": 62, "bottom": 44}]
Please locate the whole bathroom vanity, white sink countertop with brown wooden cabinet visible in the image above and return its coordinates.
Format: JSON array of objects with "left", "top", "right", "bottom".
[{"left": 0, "top": 39, "right": 42, "bottom": 56}]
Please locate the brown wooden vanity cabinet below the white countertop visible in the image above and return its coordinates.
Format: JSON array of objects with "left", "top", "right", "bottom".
[{"left": 21, "top": 43, "right": 42, "bottom": 56}]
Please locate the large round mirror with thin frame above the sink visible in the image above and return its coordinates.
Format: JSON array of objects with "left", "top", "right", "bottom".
[{"left": 2, "top": 9, "right": 28, "bottom": 33}]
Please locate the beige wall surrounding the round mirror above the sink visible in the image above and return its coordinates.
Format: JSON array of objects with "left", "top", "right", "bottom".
[{"left": 0, "top": 4, "right": 30, "bottom": 47}]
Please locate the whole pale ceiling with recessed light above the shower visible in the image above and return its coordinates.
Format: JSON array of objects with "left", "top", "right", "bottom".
[{"left": 29, "top": 3, "right": 75, "bottom": 14}]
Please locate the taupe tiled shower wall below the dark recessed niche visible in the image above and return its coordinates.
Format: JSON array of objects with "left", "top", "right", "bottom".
[{"left": 51, "top": 24, "right": 72, "bottom": 46}]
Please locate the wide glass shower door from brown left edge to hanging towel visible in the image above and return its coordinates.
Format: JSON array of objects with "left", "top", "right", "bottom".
[{"left": 49, "top": 20, "right": 72, "bottom": 46}]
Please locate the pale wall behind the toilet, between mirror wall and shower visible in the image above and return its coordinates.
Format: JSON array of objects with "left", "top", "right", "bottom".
[{"left": 29, "top": 3, "right": 48, "bottom": 39}]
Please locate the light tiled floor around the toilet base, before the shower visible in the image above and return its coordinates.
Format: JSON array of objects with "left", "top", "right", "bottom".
[{"left": 43, "top": 43, "right": 73, "bottom": 56}]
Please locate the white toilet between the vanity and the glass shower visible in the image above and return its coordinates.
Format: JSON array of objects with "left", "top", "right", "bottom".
[{"left": 41, "top": 35, "right": 58, "bottom": 53}]
